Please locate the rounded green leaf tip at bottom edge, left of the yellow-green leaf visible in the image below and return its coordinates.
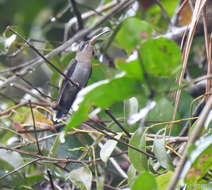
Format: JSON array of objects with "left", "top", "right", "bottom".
[{"left": 131, "top": 172, "right": 157, "bottom": 190}]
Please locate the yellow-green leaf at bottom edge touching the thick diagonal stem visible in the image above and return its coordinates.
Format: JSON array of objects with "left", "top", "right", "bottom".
[{"left": 156, "top": 171, "right": 173, "bottom": 190}]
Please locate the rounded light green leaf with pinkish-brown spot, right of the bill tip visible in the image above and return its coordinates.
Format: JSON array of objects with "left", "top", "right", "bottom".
[{"left": 116, "top": 17, "right": 152, "bottom": 52}]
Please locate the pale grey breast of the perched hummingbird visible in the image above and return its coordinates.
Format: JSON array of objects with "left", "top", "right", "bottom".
[{"left": 71, "top": 63, "right": 91, "bottom": 87}]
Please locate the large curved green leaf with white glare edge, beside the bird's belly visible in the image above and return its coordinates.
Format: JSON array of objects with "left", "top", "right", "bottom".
[{"left": 66, "top": 75, "right": 142, "bottom": 131}]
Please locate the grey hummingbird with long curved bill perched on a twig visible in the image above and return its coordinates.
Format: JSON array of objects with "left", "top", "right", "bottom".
[{"left": 54, "top": 31, "right": 109, "bottom": 119}]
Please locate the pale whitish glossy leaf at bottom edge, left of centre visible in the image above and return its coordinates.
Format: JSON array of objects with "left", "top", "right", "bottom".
[{"left": 69, "top": 167, "right": 92, "bottom": 190}]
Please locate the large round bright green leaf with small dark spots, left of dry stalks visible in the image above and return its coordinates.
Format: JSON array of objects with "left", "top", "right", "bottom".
[{"left": 140, "top": 38, "right": 181, "bottom": 76}]
